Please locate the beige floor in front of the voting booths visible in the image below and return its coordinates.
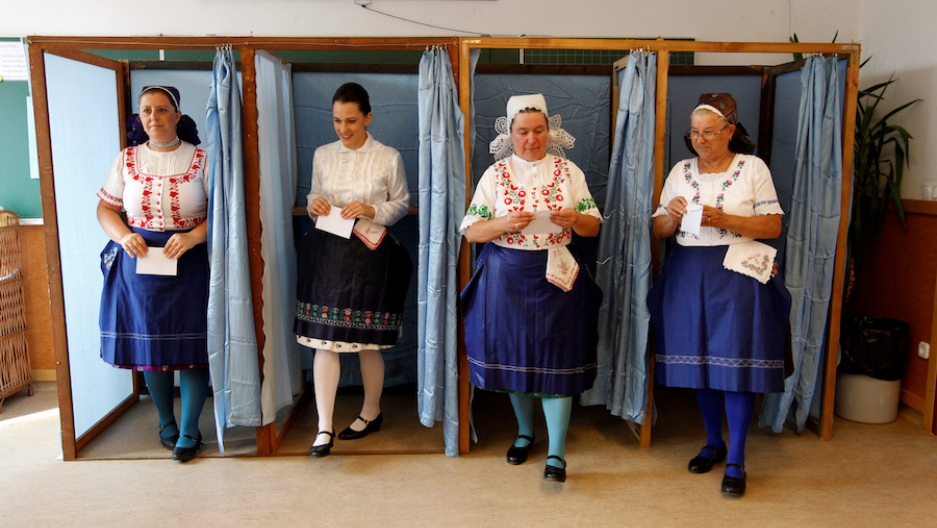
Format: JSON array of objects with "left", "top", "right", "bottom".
[{"left": 0, "top": 384, "right": 937, "bottom": 528}]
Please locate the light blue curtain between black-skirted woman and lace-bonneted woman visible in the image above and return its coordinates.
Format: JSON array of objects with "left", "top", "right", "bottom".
[{"left": 417, "top": 47, "right": 465, "bottom": 456}]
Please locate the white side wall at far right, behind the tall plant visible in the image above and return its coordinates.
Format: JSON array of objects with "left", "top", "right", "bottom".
[{"left": 859, "top": 0, "right": 937, "bottom": 199}]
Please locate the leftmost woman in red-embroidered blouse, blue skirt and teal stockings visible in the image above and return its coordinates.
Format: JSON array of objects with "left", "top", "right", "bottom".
[{"left": 97, "top": 86, "right": 209, "bottom": 462}]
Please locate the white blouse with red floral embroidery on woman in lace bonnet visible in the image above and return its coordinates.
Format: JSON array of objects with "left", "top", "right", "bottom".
[{"left": 459, "top": 154, "right": 602, "bottom": 250}]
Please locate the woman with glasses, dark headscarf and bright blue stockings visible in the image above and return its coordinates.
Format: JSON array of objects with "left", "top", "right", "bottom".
[{"left": 648, "top": 93, "right": 791, "bottom": 496}]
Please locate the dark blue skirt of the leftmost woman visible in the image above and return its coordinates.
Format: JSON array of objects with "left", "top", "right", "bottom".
[{"left": 99, "top": 228, "right": 208, "bottom": 371}]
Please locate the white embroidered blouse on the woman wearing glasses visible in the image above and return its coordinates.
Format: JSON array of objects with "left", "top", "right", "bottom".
[{"left": 654, "top": 154, "right": 784, "bottom": 246}]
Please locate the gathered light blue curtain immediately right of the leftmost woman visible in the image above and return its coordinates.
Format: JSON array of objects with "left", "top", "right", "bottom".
[{"left": 205, "top": 48, "right": 261, "bottom": 451}]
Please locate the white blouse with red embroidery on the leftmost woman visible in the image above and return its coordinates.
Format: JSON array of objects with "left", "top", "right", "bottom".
[{"left": 98, "top": 142, "right": 208, "bottom": 231}]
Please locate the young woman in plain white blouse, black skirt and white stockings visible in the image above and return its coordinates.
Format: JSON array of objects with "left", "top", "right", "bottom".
[{"left": 293, "top": 83, "right": 413, "bottom": 457}]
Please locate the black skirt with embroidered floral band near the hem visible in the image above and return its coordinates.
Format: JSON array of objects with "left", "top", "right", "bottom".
[{"left": 293, "top": 228, "right": 413, "bottom": 346}]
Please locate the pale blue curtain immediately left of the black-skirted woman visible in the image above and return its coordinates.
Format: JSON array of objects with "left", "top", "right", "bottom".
[{"left": 254, "top": 51, "right": 302, "bottom": 425}]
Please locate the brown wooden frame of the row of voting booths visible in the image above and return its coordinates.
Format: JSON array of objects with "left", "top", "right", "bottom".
[{"left": 27, "top": 36, "right": 876, "bottom": 460}]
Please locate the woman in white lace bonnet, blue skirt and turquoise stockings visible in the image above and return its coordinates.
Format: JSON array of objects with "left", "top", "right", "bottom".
[{"left": 460, "top": 94, "right": 602, "bottom": 482}]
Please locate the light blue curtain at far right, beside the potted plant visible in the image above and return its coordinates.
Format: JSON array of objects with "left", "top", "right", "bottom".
[{"left": 759, "top": 57, "right": 843, "bottom": 433}]
